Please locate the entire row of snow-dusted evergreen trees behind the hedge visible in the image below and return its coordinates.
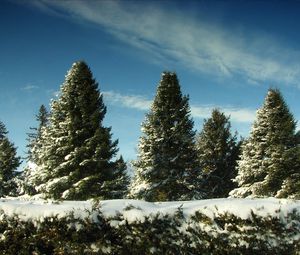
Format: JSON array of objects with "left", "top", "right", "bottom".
[{"left": 0, "top": 61, "right": 300, "bottom": 201}]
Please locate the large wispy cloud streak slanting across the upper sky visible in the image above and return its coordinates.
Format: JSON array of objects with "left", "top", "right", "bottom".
[{"left": 31, "top": 0, "right": 300, "bottom": 84}]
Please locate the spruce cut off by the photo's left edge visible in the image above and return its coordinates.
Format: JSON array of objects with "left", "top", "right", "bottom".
[{"left": 0, "top": 121, "right": 21, "bottom": 197}]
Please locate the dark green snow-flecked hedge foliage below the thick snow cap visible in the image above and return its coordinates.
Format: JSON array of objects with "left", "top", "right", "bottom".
[{"left": 0, "top": 207, "right": 300, "bottom": 255}]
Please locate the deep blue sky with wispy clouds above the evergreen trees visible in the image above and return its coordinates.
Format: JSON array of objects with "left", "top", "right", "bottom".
[{"left": 0, "top": 0, "right": 300, "bottom": 165}]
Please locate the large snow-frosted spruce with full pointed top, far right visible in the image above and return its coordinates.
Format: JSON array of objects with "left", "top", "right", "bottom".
[{"left": 230, "top": 89, "right": 299, "bottom": 197}]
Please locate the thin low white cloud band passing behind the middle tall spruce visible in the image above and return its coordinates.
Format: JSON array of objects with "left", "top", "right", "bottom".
[{"left": 103, "top": 91, "right": 256, "bottom": 123}]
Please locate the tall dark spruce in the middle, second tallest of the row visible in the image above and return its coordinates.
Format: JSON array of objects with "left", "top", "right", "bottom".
[{"left": 130, "top": 72, "right": 202, "bottom": 201}]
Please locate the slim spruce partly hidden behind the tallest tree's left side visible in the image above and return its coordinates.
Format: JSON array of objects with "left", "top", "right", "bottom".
[{"left": 20, "top": 105, "right": 49, "bottom": 195}]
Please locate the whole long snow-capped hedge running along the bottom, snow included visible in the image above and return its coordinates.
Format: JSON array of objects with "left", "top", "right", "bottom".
[{"left": 0, "top": 199, "right": 300, "bottom": 255}]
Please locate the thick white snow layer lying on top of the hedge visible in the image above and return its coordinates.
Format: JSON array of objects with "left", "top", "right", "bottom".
[{"left": 0, "top": 198, "right": 300, "bottom": 222}]
